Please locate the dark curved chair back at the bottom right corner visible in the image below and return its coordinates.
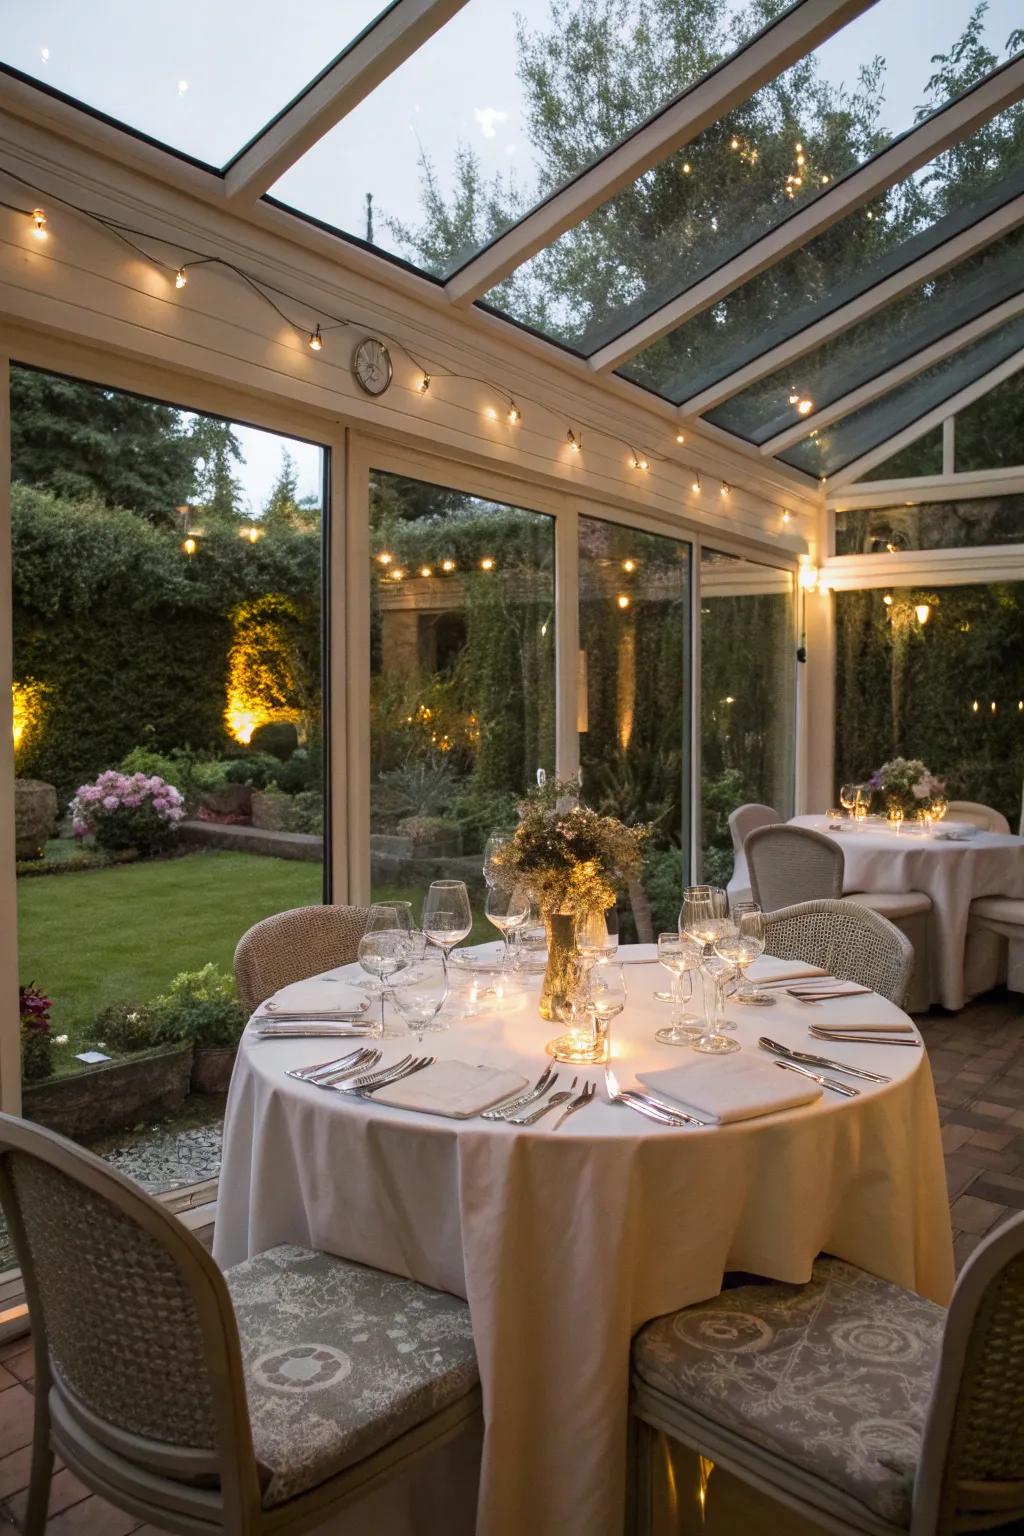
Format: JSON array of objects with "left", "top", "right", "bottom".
[{"left": 910, "top": 1212, "right": 1024, "bottom": 1536}]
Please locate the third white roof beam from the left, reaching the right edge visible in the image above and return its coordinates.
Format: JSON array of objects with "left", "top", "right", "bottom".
[{"left": 590, "top": 54, "right": 1024, "bottom": 373}]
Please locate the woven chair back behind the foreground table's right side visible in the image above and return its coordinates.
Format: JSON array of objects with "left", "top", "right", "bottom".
[{"left": 765, "top": 900, "right": 913, "bottom": 1008}]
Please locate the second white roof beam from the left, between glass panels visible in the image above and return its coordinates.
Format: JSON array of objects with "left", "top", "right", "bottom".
[{"left": 445, "top": 0, "right": 875, "bottom": 304}]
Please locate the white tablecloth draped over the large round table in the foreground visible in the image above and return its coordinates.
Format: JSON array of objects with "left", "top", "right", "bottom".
[{"left": 213, "top": 946, "right": 953, "bottom": 1536}]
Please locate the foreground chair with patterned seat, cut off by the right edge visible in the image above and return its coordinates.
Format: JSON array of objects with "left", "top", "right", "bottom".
[{"left": 633, "top": 1215, "right": 1024, "bottom": 1536}]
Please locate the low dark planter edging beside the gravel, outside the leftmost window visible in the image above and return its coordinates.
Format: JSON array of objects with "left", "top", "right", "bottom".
[{"left": 21, "top": 1041, "right": 192, "bottom": 1141}]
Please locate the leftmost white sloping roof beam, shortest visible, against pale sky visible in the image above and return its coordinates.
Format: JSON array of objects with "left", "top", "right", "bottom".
[{"left": 224, "top": 0, "right": 465, "bottom": 203}]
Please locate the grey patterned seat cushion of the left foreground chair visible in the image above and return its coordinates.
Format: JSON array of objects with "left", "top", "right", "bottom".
[{"left": 224, "top": 1246, "right": 479, "bottom": 1507}]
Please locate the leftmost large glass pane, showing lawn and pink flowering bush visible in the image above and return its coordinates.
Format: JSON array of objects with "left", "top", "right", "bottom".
[{"left": 8, "top": 369, "right": 325, "bottom": 1204}]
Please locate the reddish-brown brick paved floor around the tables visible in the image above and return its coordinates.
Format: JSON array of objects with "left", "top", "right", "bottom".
[{"left": 0, "top": 994, "right": 1024, "bottom": 1536}]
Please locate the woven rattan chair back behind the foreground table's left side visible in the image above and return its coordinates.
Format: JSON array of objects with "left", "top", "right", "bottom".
[{"left": 235, "top": 906, "right": 367, "bottom": 1012}]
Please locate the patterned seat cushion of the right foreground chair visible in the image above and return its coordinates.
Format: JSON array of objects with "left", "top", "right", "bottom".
[{"left": 633, "top": 1258, "right": 946, "bottom": 1527}]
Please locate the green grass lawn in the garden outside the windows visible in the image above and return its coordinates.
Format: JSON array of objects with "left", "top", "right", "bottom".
[{"left": 18, "top": 845, "right": 496, "bottom": 1055}]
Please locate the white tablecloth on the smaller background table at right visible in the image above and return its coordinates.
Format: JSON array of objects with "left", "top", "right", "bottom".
[{"left": 792, "top": 816, "right": 1024, "bottom": 1009}]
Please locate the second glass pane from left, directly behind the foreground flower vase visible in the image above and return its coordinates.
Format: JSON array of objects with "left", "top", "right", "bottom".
[{"left": 370, "top": 472, "right": 554, "bottom": 915}]
